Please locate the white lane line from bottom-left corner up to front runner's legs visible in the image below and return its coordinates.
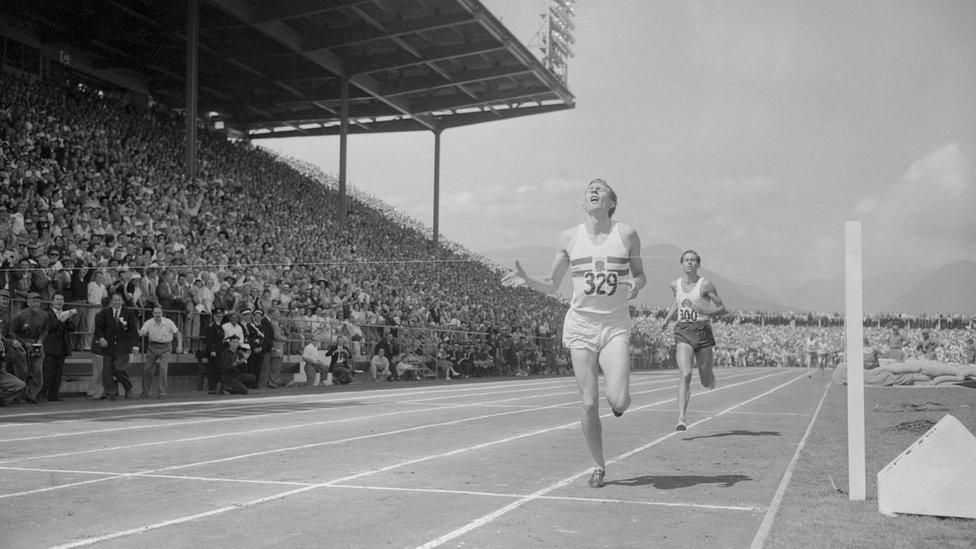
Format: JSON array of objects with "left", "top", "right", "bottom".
[{"left": 47, "top": 372, "right": 799, "bottom": 549}]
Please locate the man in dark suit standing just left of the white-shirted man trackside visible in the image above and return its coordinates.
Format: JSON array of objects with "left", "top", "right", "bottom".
[{"left": 92, "top": 294, "right": 139, "bottom": 400}]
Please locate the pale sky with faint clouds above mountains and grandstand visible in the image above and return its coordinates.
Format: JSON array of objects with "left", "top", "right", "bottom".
[{"left": 255, "top": 0, "right": 976, "bottom": 288}]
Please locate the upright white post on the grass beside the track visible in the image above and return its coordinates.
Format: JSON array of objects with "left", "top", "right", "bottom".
[{"left": 844, "top": 221, "right": 866, "bottom": 501}]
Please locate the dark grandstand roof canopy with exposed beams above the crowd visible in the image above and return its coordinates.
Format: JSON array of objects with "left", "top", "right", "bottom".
[{"left": 0, "top": 0, "right": 574, "bottom": 138}]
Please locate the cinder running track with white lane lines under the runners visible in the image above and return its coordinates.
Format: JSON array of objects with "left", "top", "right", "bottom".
[{"left": 0, "top": 369, "right": 825, "bottom": 548}]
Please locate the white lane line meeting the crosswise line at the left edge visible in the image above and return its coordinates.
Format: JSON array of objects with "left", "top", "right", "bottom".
[{"left": 0, "top": 374, "right": 764, "bottom": 464}]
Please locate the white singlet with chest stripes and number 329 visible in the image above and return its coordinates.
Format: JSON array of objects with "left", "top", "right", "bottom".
[{"left": 569, "top": 223, "right": 630, "bottom": 320}]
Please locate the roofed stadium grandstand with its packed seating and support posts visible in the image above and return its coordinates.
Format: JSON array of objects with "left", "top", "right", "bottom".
[{"left": 0, "top": 0, "right": 573, "bottom": 402}]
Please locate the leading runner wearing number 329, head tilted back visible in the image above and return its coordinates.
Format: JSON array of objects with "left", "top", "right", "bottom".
[{"left": 503, "top": 179, "right": 647, "bottom": 488}]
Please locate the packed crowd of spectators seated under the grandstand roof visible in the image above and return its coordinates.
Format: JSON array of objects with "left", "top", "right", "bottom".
[{"left": 0, "top": 72, "right": 565, "bottom": 402}]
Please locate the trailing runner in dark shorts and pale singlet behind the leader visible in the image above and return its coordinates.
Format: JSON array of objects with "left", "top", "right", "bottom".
[{"left": 661, "top": 250, "right": 726, "bottom": 431}]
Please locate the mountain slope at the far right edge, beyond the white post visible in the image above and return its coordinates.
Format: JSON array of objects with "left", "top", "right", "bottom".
[{"left": 885, "top": 259, "right": 976, "bottom": 314}]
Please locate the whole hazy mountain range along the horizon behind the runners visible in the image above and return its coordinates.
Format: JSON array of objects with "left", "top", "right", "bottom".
[{"left": 483, "top": 244, "right": 976, "bottom": 314}]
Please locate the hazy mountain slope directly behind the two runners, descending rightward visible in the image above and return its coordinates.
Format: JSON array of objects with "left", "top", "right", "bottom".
[{"left": 484, "top": 244, "right": 785, "bottom": 311}]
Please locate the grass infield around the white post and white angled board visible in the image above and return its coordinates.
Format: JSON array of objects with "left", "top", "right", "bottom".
[{"left": 765, "top": 385, "right": 976, "bottom": 548}]
